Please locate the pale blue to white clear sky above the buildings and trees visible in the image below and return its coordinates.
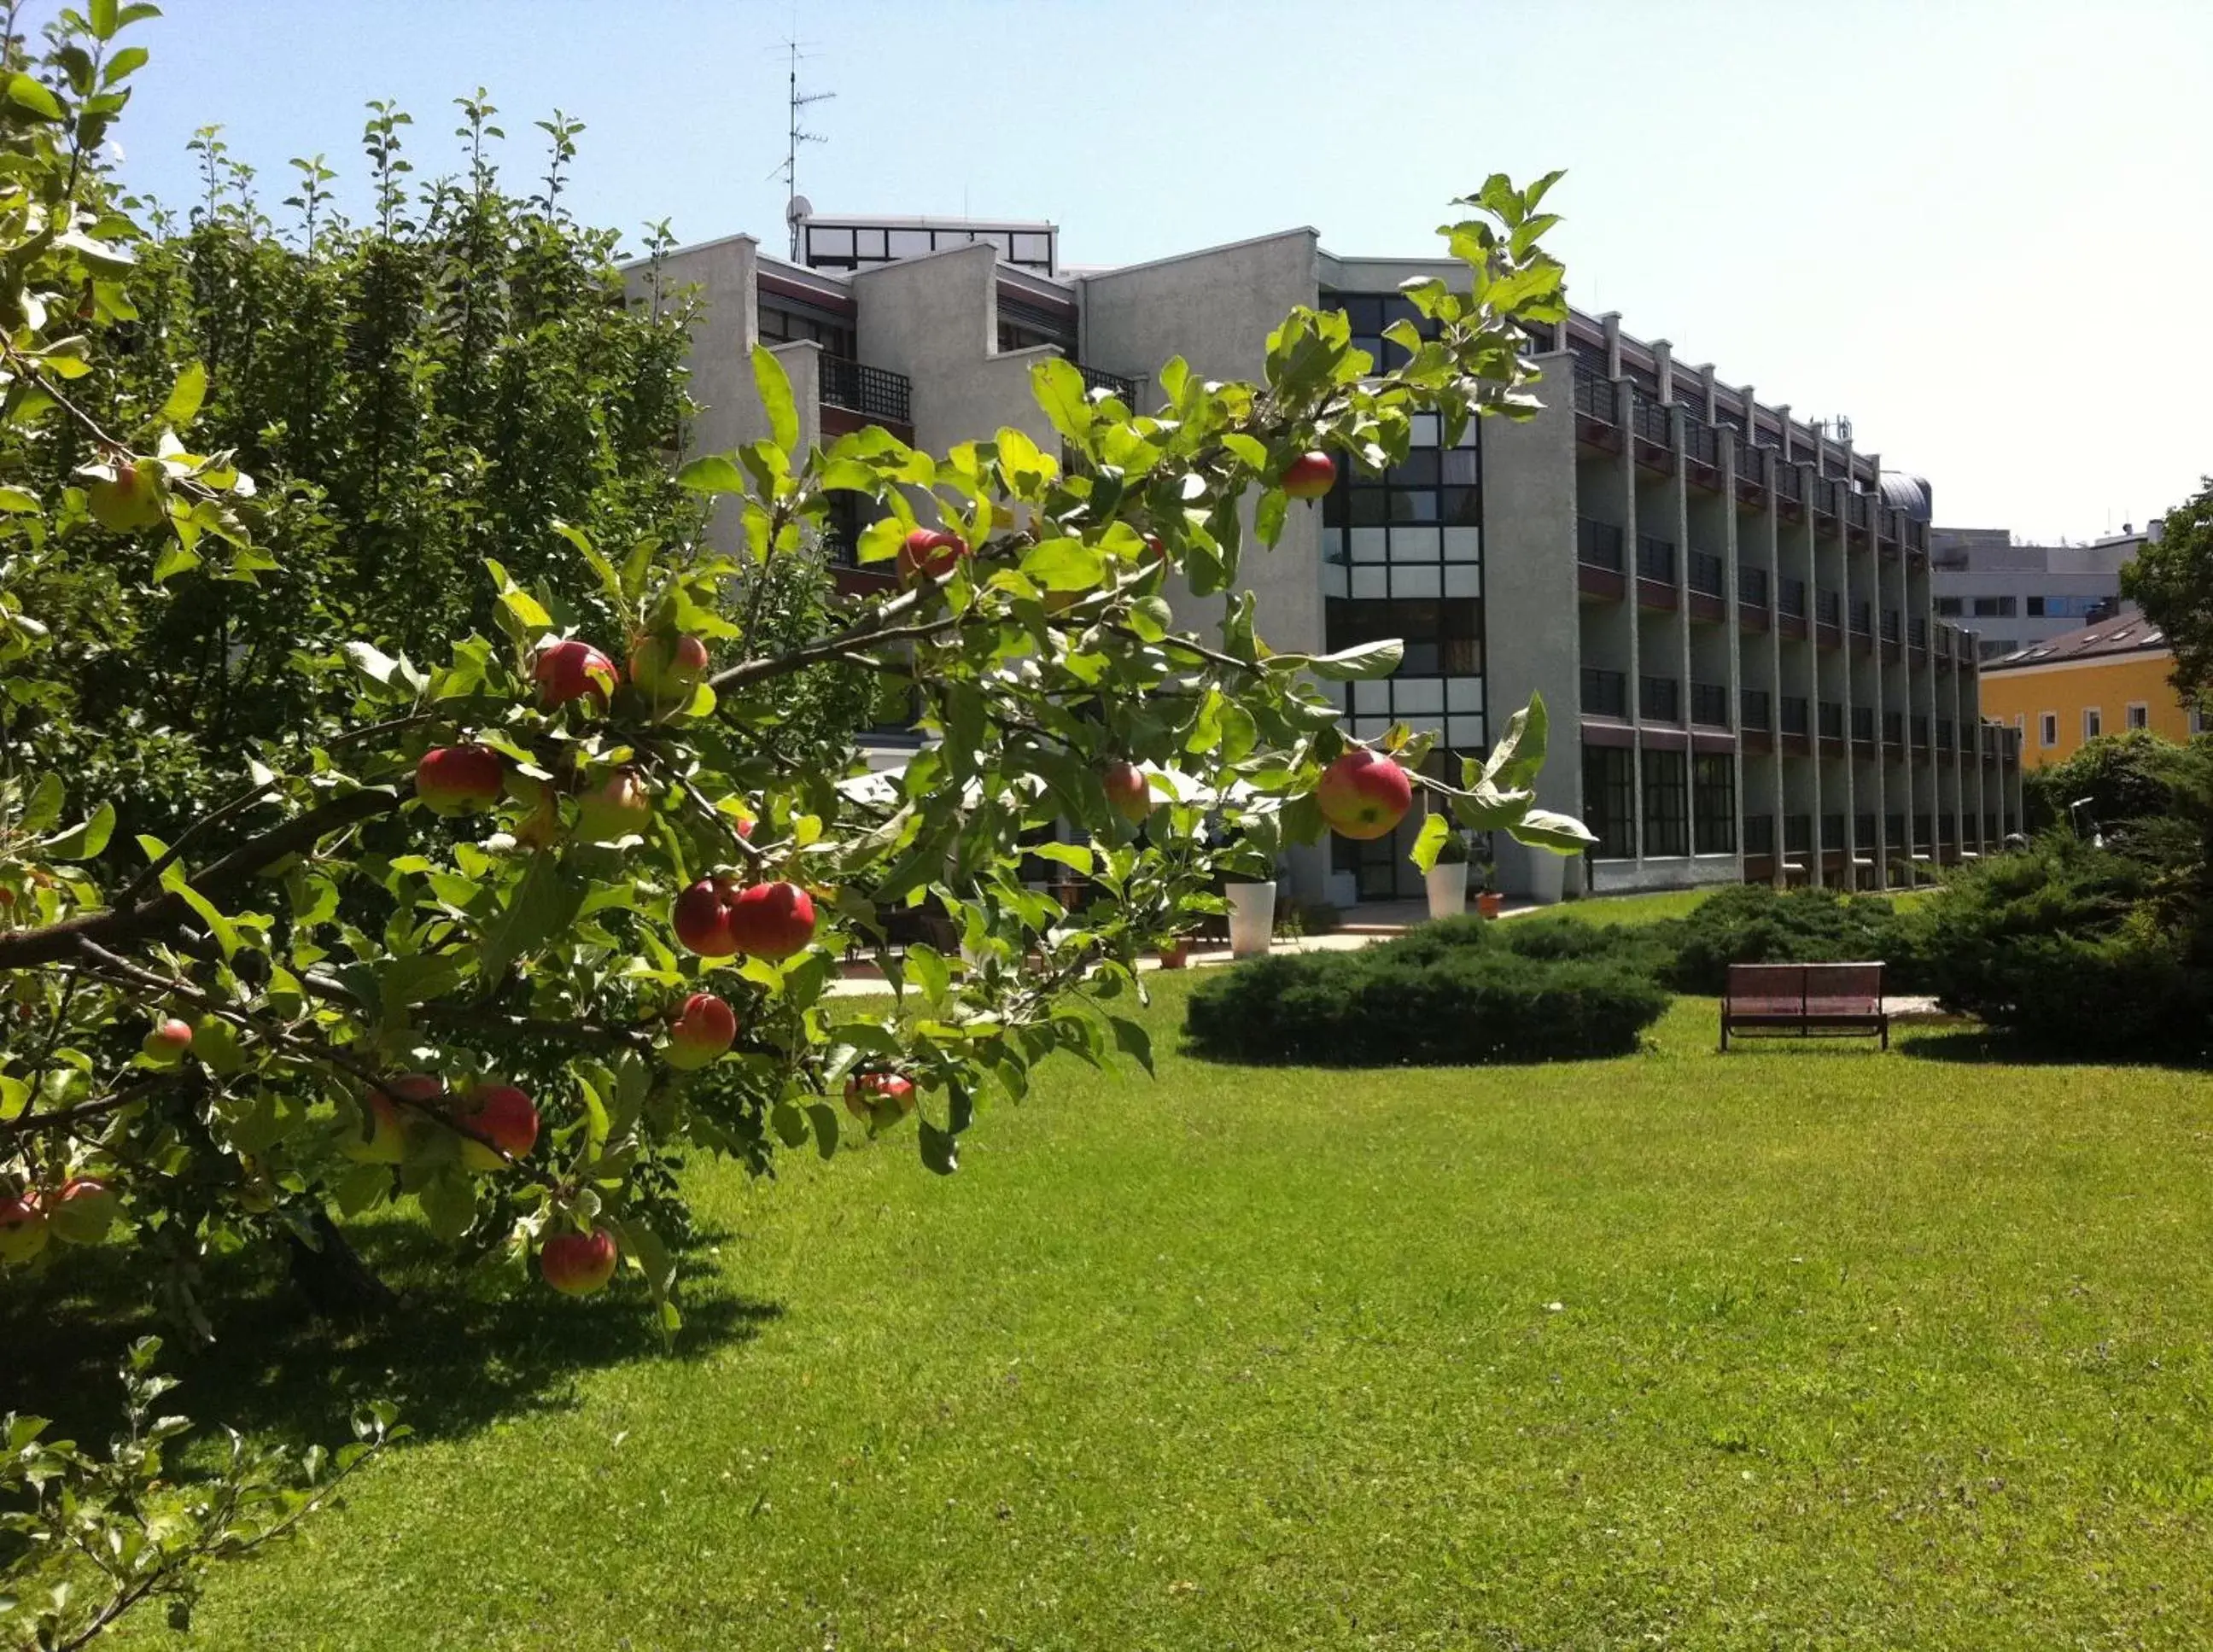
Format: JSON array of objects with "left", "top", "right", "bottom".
[{"left": 108, "top": 0, "right": 2213, "bottom": 537}]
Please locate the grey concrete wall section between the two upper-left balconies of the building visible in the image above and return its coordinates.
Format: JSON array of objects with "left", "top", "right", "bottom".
[{"left": 852, "top": 241, "right": 1060, "bottom": 453}]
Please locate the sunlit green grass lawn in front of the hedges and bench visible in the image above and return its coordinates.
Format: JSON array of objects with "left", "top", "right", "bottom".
[{"left": 30, "top": 990, "right": 2213, "bottom": 1652}]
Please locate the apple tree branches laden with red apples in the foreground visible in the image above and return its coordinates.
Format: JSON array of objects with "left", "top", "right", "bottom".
[{"left": 0, "top": 22, "right": 1585, "bottom": 1331}]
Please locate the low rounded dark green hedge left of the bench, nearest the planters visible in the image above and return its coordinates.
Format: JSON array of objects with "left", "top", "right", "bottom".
[{"left": 1184, "top": 918, "right": 1668, "bottom": 1066}]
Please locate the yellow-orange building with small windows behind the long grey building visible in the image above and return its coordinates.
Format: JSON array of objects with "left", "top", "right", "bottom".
[{"left": 1982, "top": 613, "right": 2204, "bottom": 769}]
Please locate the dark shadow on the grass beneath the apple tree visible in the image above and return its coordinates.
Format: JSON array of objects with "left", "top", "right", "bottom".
[{"left": 0, "top": 1218, "right": 784, "bottom": 1445}]
